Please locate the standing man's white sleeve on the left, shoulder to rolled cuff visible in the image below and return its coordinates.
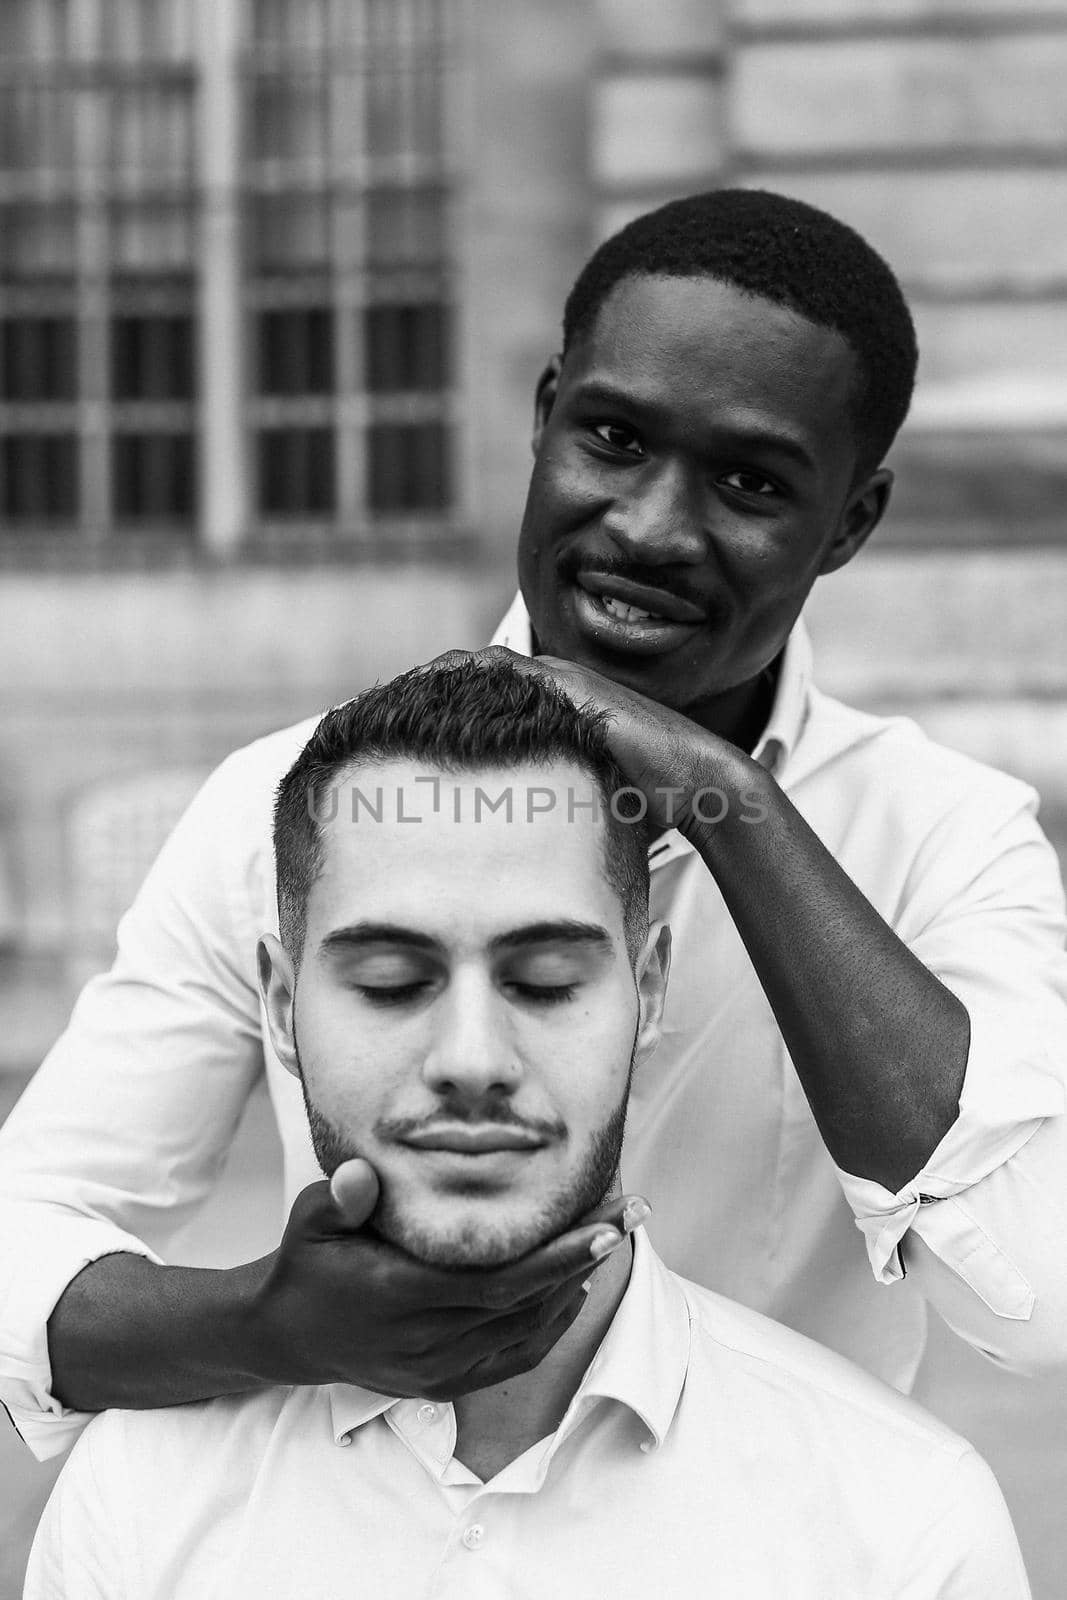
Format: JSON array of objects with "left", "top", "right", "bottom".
[{"left": 0, "top": 746, "right": 283, "bottom": 1459}]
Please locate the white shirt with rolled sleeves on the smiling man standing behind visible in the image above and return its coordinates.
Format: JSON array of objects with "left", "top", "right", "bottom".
[{"left": 0, "top": 600, "right": 1067, "bottom": 1458}]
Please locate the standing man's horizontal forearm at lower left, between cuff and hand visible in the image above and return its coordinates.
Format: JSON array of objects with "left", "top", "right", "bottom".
[{"left": 48, "top": 1254, "right": 262, "bottom": 1411}]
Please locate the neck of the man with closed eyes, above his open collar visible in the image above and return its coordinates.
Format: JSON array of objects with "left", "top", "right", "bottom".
[{"left": 454, "top": 1238, "right": 633, "bottom": 1483}]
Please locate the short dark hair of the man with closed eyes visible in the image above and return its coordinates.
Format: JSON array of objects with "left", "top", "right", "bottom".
[{"left": 274, "top": 659, "right": 648, "bottom": 966}]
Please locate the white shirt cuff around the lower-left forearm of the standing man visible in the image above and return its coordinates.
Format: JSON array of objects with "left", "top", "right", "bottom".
[{"left": 0, "top": 1203, "right": 163, "bottom": 1461}]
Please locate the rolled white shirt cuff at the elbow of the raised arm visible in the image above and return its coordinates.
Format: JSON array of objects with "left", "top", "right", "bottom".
[{"left": 837, "top": 1010, "right": 1067, "bottom": 1317}]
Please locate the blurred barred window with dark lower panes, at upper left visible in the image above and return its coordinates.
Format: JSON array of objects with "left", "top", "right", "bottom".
[{"left": 0, "top": 0, "right": 462, "bottom": 550}]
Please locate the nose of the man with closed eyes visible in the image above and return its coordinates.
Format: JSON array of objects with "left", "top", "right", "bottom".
[{"left": 422, "top": 976, "right": 522, "bottom": 1099}]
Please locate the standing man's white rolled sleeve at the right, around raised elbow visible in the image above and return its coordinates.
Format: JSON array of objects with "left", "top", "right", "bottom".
[{"left": 838, "top": 781, "right": 1067, "bottom": 1371}]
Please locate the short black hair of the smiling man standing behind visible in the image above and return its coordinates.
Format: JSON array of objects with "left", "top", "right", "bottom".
[{"left": 563, "top": 189, "right": 918, "bottom": 474}]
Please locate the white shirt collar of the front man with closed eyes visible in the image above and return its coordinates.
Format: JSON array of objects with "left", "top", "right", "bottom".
[{"left": 328, "top": 1229, "right": 689, "bottom": 1467}]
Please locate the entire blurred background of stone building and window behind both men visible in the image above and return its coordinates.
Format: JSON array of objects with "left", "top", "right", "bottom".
[{"left": 0, "top": 0, "right": 1067, "bottom": 1600}]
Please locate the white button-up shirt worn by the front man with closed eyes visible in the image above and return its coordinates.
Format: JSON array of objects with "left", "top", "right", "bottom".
[{"left": 24, "top": 1235, "right": 1030, "bottom": 1600}]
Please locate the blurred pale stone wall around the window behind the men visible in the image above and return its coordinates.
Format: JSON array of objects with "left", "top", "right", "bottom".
[{"left": 0, "top": 0, "right": 1067, "bottom": 1067}]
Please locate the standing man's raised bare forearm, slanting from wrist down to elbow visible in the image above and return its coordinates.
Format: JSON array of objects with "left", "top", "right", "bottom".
[{"left": 685, "top": 750, "right": 969, "bottom": 1194}]
